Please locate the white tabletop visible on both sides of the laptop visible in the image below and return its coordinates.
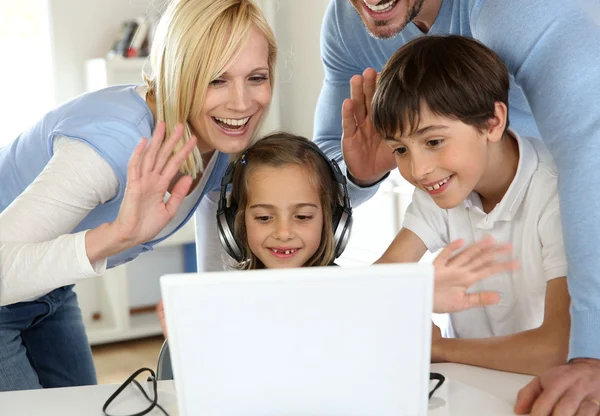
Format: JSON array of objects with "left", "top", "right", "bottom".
[{"left": 0, "top": 364, "right": 532, "bottom": 416}]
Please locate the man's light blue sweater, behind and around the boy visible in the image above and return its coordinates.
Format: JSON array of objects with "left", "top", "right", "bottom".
[{"left": 314, "top": 0, "right": 600, "bottom": 359}]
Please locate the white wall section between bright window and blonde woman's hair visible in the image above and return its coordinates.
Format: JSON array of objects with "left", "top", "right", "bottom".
[{"left": 47, "top": 0, "right": 164, "bottom": 104}]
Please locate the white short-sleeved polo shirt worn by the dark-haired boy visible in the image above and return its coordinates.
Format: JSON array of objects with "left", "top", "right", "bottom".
[{"left": 403, "top": 130, "right": 567, "bottom": 338}]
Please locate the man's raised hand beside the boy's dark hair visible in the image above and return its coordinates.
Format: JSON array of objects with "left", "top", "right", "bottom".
[{"left": 342, "top": 68, "right": 396, "bottom": 186}]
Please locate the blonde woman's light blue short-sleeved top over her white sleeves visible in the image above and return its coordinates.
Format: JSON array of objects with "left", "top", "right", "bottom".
[{"left": 0, "top": 85, "right": 229, "bottom": 268}]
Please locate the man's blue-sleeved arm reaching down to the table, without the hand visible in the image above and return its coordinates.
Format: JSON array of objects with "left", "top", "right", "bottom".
[{"left": 473, "top": 0, "right": 600, "bottom": 359}]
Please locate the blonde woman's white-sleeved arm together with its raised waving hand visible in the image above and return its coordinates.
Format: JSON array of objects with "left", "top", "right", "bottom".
[{"left": 0, "top": 122, "right": 196, "bottom": 305}]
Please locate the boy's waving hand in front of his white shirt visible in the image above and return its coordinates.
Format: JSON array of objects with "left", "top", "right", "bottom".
[{"left": 433, "top": 236, "right": 519, "bottom": 313}]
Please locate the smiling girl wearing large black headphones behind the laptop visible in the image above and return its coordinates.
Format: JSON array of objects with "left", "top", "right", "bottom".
[{"left": 217, "top": 133, "right": 352, "bottom": 269}]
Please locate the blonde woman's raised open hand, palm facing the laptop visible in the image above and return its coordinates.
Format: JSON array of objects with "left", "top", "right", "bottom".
[{"left": 111, "top": 122, "right": 196, "bottom": 247}]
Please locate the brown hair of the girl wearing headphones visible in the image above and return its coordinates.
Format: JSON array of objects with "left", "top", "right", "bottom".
[{"left": 230, "top": 132, "right": 343, "bottom": 270}]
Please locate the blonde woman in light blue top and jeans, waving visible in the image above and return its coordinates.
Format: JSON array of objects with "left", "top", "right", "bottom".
[{"left": 0, "top": 0, "right": 276, "bottom": 391}]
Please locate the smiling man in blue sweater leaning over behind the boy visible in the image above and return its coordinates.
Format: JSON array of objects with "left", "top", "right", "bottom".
[{"left": 314, "top": 0, "right": 600, "bottom": 416}]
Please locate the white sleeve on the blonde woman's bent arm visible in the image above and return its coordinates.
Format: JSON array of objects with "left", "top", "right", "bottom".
[{"left": 0, "top": 138, "right": 119, "bottom": 305}]
